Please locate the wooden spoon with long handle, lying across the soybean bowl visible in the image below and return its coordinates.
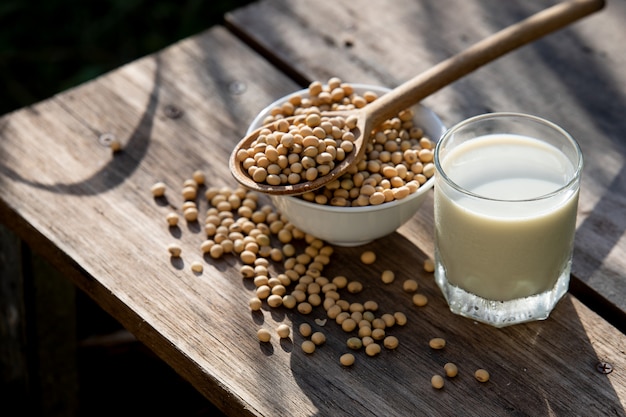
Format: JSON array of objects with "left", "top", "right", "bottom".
[{"left": 229, "top": 0, "right": 605, "bottom": 195}]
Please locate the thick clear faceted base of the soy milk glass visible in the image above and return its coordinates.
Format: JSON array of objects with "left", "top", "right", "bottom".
[{"left": 435, "top": 261, "right": 571, "bottom": 327}]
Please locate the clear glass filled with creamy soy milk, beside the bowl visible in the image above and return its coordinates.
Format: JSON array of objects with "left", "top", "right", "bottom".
[{"left": 434, "top": 113, "right": 583, "bottom": 327}]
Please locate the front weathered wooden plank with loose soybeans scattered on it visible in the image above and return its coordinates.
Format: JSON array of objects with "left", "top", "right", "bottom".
[{"left": 0, "top": 17, "right": 626, "bottom": 416}]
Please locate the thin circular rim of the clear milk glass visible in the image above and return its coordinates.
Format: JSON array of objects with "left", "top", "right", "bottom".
[{"left": 434, "top": 112, "right": 583, "bottom": 203}]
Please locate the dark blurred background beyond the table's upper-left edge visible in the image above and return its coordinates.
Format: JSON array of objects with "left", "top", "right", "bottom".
[{"left": 0, "top": 0, "right": 252, "bottom": 114}]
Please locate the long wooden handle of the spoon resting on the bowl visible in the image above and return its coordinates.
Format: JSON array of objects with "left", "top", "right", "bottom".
[{"left": 365, "top": 0, "right": 605, "bottom": 127}]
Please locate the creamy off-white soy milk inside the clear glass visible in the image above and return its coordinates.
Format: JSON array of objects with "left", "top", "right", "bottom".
[{"left": 435, "top": 134, "right": 578, "bottom": 301}]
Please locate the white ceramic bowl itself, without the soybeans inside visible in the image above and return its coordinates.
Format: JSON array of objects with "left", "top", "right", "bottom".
[{"left": 248, "top": 84, "right": 445, "bottom": 246}]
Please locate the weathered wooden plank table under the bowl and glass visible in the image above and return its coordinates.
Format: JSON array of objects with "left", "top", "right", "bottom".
[{"left": 0, "top": 0, "right": 626, "bottom": 416}]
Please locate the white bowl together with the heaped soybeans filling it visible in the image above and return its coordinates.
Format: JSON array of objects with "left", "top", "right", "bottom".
[{"left": 239, "top": 77, "right": 445, "bottom": 246}]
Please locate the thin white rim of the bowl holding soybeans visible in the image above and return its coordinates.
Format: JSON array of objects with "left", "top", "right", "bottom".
[{"left": 246, "top": 83, "right": 447, "bottom": 213}]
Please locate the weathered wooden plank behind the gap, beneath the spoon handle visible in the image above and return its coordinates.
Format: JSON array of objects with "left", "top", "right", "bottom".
[{"left": 228, "top": 0, "right": 626, "bottom": 322}]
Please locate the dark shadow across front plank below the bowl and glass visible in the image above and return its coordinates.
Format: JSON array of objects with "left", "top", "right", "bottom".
[{"left": 291, "top": 233, "right": 624, "bottom": 416}]
